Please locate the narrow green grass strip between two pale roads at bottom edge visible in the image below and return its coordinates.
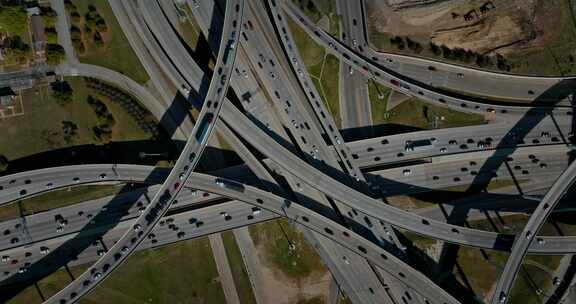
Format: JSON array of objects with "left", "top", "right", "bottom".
[{"left": 222, "top": 231, "right": 256, "bottom": 304}]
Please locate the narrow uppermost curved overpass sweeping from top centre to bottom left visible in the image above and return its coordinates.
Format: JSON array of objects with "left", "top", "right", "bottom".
[{"left": 40, "top": 0, "right": 244, "bottom": 304}]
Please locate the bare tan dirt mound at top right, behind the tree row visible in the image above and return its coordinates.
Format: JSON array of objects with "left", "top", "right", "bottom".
[{"left": 367, "top": 0, "right": 543, "bottom": 54}]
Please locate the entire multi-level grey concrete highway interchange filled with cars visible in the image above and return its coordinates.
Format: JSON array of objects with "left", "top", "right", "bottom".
[{"left": 0, "top": 0, "right": 576, "bottom": 304}]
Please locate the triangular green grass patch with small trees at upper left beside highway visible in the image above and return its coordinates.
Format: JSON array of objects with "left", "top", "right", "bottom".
[{"left": 68, "top": 0, "right": 149, "bottom": 84}]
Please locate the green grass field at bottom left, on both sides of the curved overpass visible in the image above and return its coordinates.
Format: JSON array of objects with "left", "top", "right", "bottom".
[{"left": 9, "top": 238, "right": 225, "bottom": 304}]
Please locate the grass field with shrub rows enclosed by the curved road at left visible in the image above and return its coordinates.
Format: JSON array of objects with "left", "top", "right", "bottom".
[{"left": 0, "top": 77, "right": 150, "bottom": 160}]
